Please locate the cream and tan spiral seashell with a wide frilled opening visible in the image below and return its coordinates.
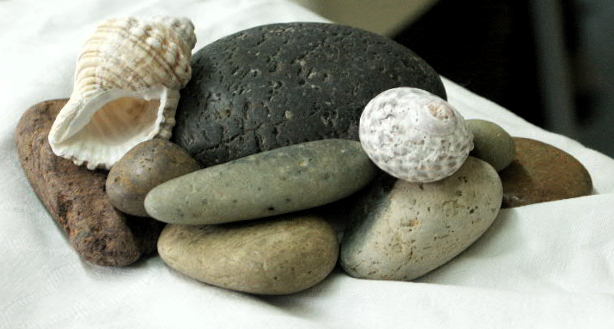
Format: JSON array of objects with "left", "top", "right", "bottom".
[{"left": 49, "top": 17, "right": 196, "bottom": 170}]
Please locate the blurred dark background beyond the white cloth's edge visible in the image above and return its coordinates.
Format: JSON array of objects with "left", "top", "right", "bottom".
[{"left": 293, "top": 0, "right": 614, "bottom": 156}]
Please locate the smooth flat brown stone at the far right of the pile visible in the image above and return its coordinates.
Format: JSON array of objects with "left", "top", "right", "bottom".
[{"left": 499, "top": 137, "right": 593, "bottom": 208}]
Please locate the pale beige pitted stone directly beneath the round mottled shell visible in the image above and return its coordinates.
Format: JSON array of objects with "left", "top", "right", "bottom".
[{"left": 340, "top": 156, "right": 503, "bottom": 281}]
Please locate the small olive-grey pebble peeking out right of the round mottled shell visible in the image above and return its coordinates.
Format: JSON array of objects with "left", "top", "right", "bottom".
[{"left": 467, "top": 119, "right": 516, "bottom": 171}]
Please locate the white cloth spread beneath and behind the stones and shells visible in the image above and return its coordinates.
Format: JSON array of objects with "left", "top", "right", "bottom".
[{"left": 0, "top": 0, "right": 614, "bottom": 329}]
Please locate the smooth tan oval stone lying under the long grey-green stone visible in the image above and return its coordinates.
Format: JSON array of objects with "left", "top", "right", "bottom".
[{"left": 158, "top": 215, "right": 339, "bottom": 295}]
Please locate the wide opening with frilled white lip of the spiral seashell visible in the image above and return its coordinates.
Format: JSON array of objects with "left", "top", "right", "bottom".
[{"left": 49, "top": 86, "right": 178, "bottom": 169}]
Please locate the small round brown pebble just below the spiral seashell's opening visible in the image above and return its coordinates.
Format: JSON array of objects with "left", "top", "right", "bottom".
[{"left": 106, "top": 139, "right": 200, "bottom": 217}]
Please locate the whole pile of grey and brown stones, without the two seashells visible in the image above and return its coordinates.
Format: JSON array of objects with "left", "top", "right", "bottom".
[{"left": 17, "top": 23, "right": 592, "bottom": 294}]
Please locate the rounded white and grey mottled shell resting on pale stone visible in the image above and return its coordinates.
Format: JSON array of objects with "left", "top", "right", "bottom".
[{"left": 359, "top": 87, "right": 473, "bottom": 183}]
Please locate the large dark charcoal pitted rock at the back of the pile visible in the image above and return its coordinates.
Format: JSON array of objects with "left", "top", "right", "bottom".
[{"left": 172, "top": 23, "right": 446, "bottom": 167}]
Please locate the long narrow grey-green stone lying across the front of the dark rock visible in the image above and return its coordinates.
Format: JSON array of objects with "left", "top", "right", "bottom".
[{"left": 145, "top": 139, "right": 378, "bottom": 224}]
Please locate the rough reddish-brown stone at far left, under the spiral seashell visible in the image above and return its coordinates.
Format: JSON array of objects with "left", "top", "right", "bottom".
[{"left": 16, "top": 100, "right": 163, "bottom": 266}]
